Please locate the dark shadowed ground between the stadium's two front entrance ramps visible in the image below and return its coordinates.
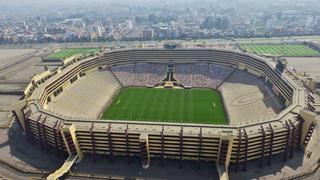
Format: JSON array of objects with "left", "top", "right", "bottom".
[{"left": 72, "top": 155, "right": 219, "bottom": 180}]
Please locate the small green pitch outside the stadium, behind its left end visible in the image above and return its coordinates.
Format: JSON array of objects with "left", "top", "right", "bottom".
[{"left": 47, "top": 48, "right": 100, "bottom": 60}]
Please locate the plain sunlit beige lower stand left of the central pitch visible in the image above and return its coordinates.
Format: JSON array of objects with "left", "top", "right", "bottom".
[{"left": 48, "top": 70, "right": 120, "bottom": 118}]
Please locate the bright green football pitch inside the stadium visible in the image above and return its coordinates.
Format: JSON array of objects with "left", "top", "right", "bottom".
[{"left": 102, "top": 88, "right": 227, "bottom": 124}]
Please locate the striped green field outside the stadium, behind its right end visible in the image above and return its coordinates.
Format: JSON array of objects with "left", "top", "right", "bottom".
[{"left": 240, "top": 44, "right": 320, "bottom": 57}]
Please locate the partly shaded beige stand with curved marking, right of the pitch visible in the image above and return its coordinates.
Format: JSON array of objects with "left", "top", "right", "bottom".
[{"left": 219, "top": 70, "right": 281, "bottom": 125}]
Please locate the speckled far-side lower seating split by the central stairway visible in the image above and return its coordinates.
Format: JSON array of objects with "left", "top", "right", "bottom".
[{"left": 111, "top": 63, "right": 233, "bottom": 89}]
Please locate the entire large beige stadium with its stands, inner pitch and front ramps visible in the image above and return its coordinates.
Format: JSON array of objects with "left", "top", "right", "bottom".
[{"left": 14, "top": 48, "right": 314, "bottom": 178}]
